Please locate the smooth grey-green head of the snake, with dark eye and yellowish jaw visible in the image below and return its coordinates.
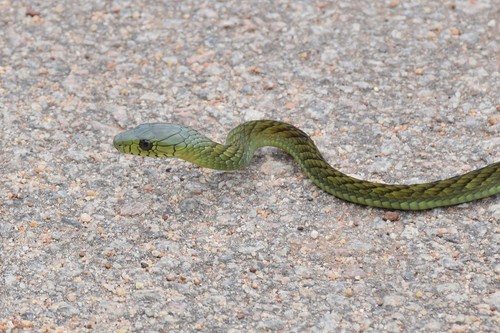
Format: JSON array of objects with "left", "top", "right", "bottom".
[{"left": 113, "top": 123, "right": 189, "bottom": 157}]
